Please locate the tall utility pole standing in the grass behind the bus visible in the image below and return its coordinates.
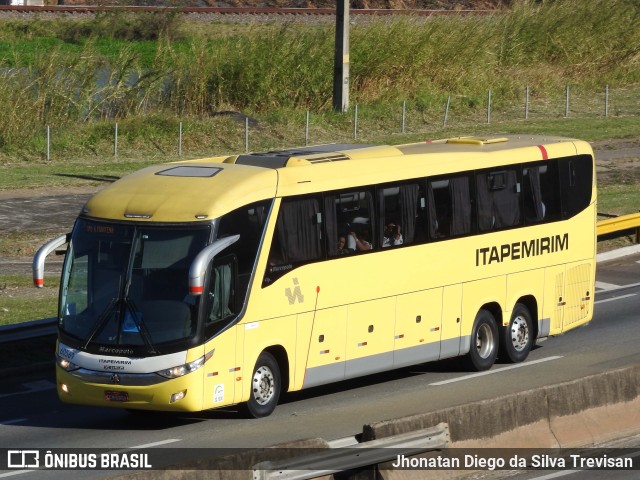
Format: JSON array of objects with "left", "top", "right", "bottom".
[{"left": 333, "top": 0, "right": 349, "bottom": 112}]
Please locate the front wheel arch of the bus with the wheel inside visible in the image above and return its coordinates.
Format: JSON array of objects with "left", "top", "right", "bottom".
[{"left": 246, "top": 347, "right": 289, "bottom": 418}]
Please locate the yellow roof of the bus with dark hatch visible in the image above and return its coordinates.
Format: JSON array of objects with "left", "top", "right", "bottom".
[{"left": 83, "top": 135, "right": 593, "bottom": 222}]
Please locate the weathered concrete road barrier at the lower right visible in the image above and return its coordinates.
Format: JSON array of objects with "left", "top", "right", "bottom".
[{"left": 362, "top": 365, "right": 640, "bottom": 447}]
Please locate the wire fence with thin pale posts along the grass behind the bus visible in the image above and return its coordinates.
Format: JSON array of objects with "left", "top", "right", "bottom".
[{"left": 41, "top": 85, "right": 640, "bottom": 161}]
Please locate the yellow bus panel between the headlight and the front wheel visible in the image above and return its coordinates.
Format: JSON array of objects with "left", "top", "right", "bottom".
[{"left": 202, "top": 327, "right": 238, "bottom": 409}]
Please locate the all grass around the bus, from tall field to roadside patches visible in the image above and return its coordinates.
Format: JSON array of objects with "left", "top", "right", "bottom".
[{"left": 0, "top": 0, "right": 640, "bottom": 324}]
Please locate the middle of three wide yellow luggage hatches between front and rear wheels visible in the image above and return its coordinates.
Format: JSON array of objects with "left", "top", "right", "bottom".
[{"left": 345, "top": 297, "right": 396, "bottom": 378}]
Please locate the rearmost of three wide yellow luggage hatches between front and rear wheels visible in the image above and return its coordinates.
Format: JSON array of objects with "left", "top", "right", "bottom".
[{"left": 393, "top": 288, "right": 442, "bottom": 367}]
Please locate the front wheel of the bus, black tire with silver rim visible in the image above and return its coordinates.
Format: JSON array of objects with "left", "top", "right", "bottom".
[{"left": 247, "top": 352, "right": 282, "bottom": 418}]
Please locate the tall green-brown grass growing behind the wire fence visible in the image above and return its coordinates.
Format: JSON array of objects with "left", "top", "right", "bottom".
[{"left": 0, "top": 0, "right": 640, "bottom": 161}]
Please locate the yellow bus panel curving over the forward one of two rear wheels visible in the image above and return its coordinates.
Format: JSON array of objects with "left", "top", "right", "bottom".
[{"left": 460, "top": 275, "right": 507, "bottom": 355}]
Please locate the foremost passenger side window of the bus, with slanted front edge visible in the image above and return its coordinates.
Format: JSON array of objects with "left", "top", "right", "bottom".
[{"left": 263, "top": 197, "right": 322, "bottom": 286}]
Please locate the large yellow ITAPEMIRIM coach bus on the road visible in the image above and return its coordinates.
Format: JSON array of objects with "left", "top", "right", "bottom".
[{"left": 34, "top": 136, "right": 596, "bottom": 417}]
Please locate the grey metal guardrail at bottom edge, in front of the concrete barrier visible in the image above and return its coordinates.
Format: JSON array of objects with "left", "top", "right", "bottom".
[{"left": 253, "top": 423, "right": 449, "bottom": 480}]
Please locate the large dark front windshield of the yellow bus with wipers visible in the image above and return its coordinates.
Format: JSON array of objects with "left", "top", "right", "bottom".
[{"left": 59, "top": 219, "right": 211, "bottom": 354}]
